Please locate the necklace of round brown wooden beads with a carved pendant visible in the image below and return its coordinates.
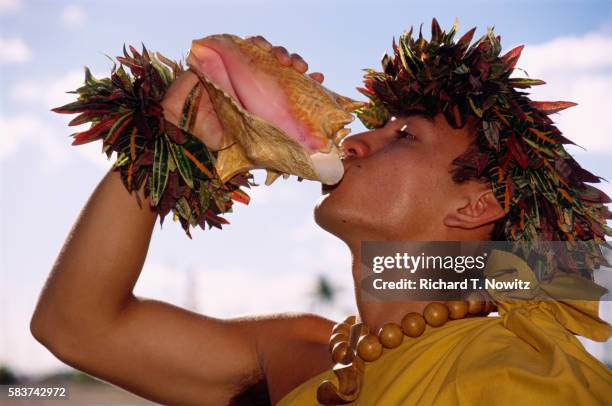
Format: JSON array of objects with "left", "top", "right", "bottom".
[{"left": 317, "top": 296, "right": 497, "bottom": 405}]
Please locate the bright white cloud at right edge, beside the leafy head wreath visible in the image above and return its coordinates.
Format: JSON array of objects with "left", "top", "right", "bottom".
[{"left": 514, "top": 33, "right": 612, "bottom": 153}]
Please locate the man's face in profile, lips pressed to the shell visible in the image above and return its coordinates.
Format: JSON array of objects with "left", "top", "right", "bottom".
[{"left": 314, "top": 114, "right": 473, "bottom": 243}]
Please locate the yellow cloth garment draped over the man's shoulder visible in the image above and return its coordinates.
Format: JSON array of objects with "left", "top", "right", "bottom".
[{"left": 278, "top": 249, "right": 612, "bottom": 406}]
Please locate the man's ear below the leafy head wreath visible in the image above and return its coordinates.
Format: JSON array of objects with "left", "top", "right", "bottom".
[{"left": 444, "top": 187, "right": 505, "bottom": 229}]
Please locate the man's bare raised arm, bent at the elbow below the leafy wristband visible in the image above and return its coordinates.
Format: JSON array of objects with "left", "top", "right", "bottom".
[{"left": 31, "top": 167, "right": 262, "bottom": 404}]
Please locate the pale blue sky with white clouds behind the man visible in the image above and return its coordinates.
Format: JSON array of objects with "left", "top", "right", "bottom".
[{"left": 0, "top": 0, "right": 612, "bottom": 372}]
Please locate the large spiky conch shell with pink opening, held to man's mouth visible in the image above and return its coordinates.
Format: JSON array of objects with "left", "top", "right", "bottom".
[{"left": 187, "top": 34, "right": 362, "bottom": 184}]
